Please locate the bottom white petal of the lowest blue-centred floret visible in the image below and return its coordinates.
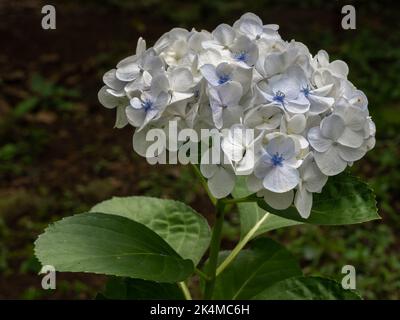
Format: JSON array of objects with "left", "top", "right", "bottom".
[{"left": 263, "top": 165, "right": 300, "bottom": 193}]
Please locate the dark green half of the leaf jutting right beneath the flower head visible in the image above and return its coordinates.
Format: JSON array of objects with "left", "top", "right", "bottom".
[{"left": 258, "top": 173, "right": 380, "bottom": 225}]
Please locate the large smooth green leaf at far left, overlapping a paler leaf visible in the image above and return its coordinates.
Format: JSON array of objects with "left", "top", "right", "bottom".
[{"left": 35, "top": 213, "right": 194, "bottom": 282}]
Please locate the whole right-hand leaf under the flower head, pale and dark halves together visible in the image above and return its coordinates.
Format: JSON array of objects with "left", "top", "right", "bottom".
[{"left": 234, "top": 173, "right": 380, "bottom": 237}]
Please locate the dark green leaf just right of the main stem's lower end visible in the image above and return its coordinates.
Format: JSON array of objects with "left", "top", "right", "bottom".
[{"left": 213, "top": 238, "right": 302, "bottom": 300}]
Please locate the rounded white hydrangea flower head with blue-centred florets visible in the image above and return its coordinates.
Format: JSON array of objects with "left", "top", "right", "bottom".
[{"left": 98, "top": 13, "right": 375, "bottom": 218}]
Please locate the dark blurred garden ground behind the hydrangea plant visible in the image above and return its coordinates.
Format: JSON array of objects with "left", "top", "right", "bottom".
[{"left": 0, "top": 0, "right": 400, "bottom": 299}]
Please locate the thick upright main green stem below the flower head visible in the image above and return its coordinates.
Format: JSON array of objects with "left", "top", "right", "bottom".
[{"left": 204, "top": 201, "right": 225, "bottom": 299}]
